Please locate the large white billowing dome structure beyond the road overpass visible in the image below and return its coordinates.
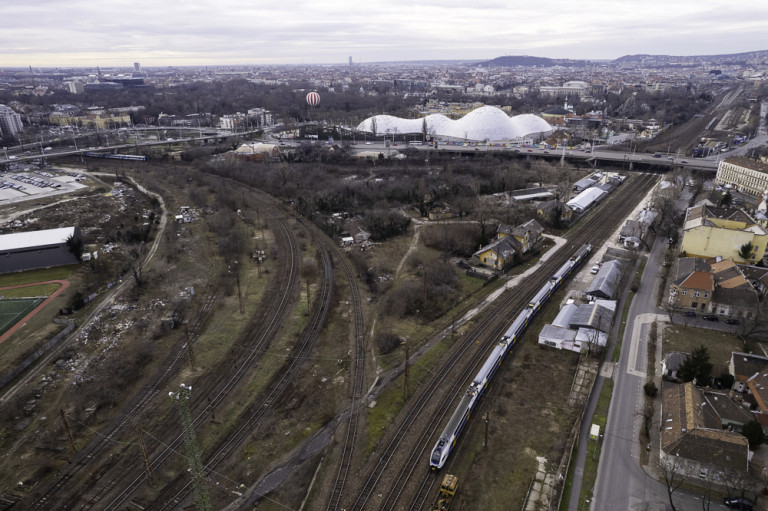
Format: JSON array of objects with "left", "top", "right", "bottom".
[{"left": 357, "top": 106, "right": 553, "bottom": 142}]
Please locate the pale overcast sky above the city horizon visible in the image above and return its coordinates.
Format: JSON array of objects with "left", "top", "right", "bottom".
[{"left": 6, "top": 0, "right": 768, "bottom": 67}]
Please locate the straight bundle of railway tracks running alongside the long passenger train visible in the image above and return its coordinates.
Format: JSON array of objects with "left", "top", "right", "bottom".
[{"left": 347, "top": 175, "right": 656, "bottom": 510}]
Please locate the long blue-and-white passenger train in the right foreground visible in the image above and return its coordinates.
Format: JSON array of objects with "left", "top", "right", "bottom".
[{"left": 429, "top": 244, "right": 592, "bottom": 470}]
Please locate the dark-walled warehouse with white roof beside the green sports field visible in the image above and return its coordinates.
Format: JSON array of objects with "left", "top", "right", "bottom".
[{"left": 0, "top": 227, "right": 80, "bottom": 273}]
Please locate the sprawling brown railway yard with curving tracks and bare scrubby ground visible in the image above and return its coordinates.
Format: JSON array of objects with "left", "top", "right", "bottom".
[{"left": 0, "top": 156, "right": 658, "bottom": 510}]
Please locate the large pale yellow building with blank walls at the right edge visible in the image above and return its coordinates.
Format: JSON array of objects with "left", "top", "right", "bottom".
[{"left": 681, "top": 205, "right": 768, "bottom": 263}]
